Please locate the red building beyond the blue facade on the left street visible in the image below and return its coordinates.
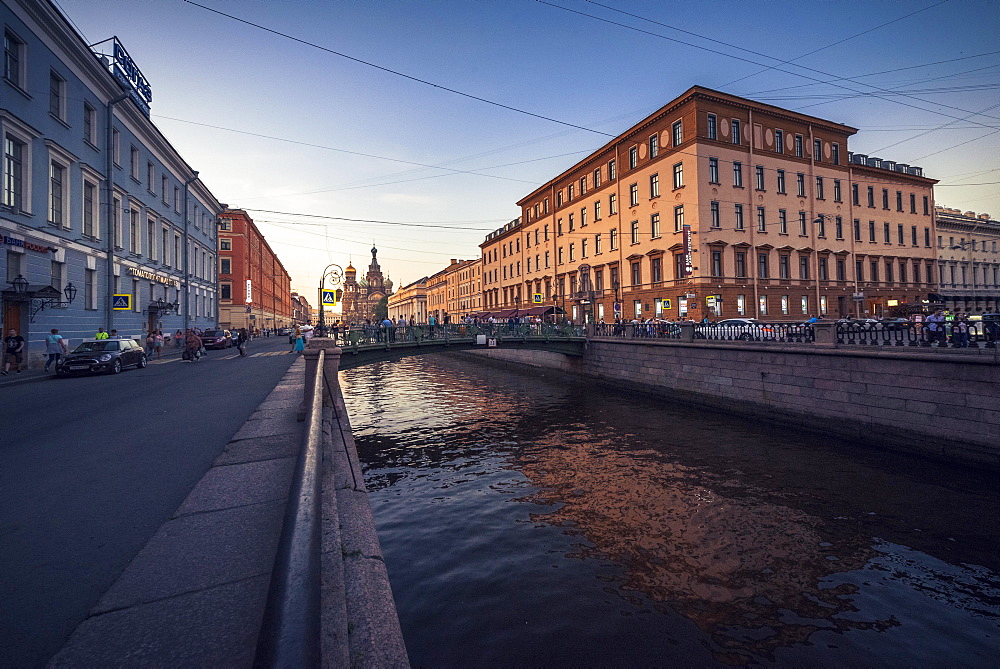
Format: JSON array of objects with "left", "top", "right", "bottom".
[{"left": 219, "top": 209, "right": 293, "bottom": 329}]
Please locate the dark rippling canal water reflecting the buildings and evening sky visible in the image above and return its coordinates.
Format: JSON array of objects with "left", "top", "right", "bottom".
[{"left": 341, "top": 355, "right": 1000, "bottom": 667}]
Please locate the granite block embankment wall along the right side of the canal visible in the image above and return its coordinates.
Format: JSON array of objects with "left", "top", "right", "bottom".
[{"left": 470, "top": 340, "right": 1000, "bottom": 470}]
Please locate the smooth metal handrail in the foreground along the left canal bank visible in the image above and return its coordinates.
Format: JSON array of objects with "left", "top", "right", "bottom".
[{"left": 254, "top": 350, "right": 326, "bottom": 667}]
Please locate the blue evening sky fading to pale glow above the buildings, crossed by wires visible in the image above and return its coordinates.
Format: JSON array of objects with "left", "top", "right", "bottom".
[{"left": 56, "top": 0, "right": 1000, "bottom": 296}]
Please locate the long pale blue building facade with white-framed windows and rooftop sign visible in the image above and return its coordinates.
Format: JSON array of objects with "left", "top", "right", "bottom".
[{"left": 0, "top": 0, "right": 225, "bottom": 365}]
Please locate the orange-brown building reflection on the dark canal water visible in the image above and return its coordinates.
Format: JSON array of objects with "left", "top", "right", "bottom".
[{"left": 517, "top": 432, "right": 894, "bottom": 663}]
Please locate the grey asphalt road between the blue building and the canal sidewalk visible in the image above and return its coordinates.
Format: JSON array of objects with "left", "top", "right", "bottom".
[{"left": 0, "top": 337, "right": 295, "bottom": 667}]
